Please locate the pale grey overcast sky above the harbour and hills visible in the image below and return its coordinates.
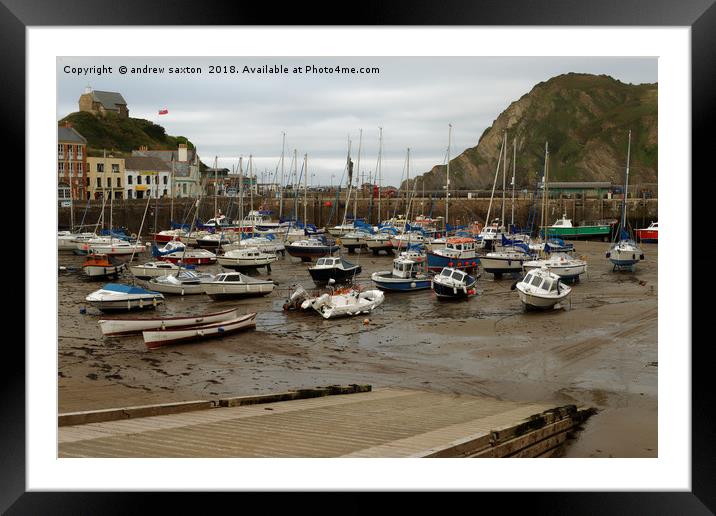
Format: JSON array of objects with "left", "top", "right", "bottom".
[{"left": 57, "top": 57, "right": 657, "bottom": 186}]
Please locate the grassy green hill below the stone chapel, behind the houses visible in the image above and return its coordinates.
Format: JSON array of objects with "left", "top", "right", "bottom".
[{"left": 59, "top": 112, "right": 199, "bottom": 156}]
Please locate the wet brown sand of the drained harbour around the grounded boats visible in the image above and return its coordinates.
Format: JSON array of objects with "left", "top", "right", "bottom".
[{"left": 58, "top": 242, "right": 658, "bottom": 457}]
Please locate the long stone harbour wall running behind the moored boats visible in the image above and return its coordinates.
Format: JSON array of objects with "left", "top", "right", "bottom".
[{"left": 58, "top": 196, "right": 658, "bottom": 235}]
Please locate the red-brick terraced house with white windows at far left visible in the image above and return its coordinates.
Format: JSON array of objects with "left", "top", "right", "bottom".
[{"left": 57, "top": 124, "right": 89, "bottom": 202}]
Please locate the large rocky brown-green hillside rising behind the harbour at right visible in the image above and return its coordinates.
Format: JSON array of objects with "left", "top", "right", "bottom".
[{"left": 411, "top": 73, "right": 658, "bottom": 190}]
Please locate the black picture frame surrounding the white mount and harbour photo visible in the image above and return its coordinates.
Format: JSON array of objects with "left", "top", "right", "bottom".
[{"left": 5, "top": 0, "right": 716, "bottom": 514}]
